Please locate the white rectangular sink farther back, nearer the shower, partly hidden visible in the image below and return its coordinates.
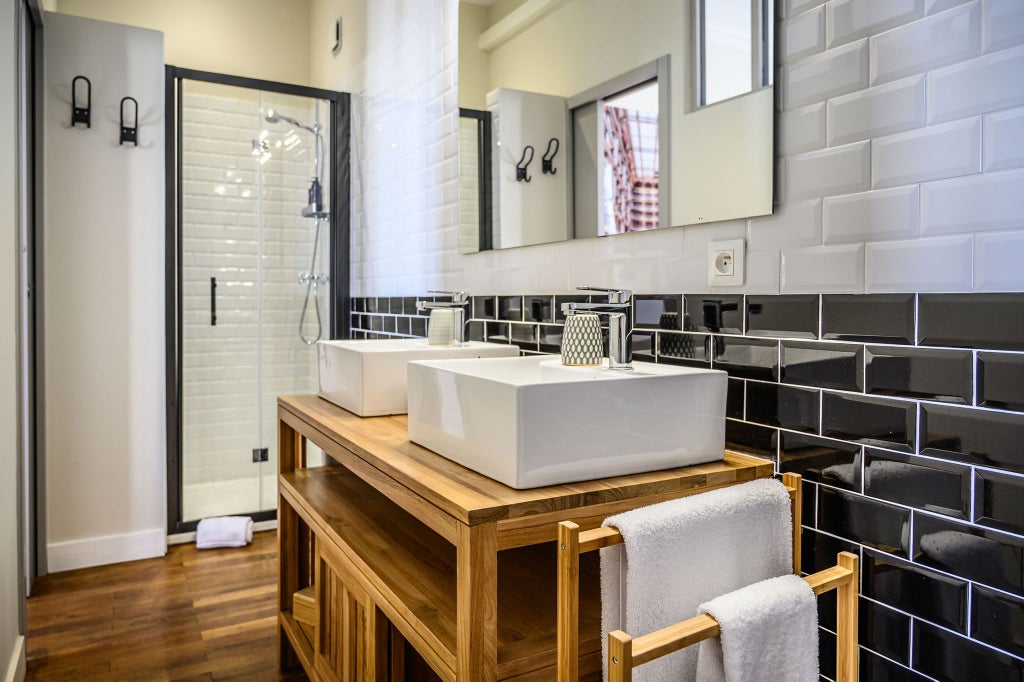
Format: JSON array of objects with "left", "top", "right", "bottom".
[{"left": 316, "top": 339, "right": 519, "bottom": 417}]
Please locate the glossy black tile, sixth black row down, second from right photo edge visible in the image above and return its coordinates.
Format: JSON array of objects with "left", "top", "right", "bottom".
[{"left": 863, "top": 550, "right": 967, "bottom": 630}]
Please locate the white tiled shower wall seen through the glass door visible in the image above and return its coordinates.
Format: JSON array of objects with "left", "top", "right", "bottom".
[{"left": 182, "top": 91, "right": 328, "bottom": 520}]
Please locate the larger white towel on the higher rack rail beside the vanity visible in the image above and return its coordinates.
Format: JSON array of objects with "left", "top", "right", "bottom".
[{"left": 601, "top": 478, "right": 793, "bottom": 682}]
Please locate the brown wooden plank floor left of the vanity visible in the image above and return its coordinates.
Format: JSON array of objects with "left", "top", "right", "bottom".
[{"left": 28, "top": 531, "right": 306, "bottom": 681}]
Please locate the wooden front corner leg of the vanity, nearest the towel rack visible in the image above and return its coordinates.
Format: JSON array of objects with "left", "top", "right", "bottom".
[{"left": 456, "top": 523, "right": 498, "bottom": 682}]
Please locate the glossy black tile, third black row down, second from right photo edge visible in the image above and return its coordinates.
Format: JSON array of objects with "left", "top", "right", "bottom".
[{"left": 821, "top": 391, "right": 918, "bottom": 451}]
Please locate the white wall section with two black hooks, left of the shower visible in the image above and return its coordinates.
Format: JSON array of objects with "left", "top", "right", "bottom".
[{"left": 41, "top": 13, "right": 166, "bottom": 571}]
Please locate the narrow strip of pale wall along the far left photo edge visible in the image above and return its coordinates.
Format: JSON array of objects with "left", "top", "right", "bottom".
[{"left": 0, "top": 0, "right": 25, "bottom": 681}]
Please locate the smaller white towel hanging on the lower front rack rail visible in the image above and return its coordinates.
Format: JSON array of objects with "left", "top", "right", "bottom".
[{"left": 696, "top": 576, "right": 818, "bottom": 682}]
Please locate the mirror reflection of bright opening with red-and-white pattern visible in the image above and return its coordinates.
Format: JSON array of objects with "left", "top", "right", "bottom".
[{"left": 598, "top": 81, "right": 658, "bottom": 236}]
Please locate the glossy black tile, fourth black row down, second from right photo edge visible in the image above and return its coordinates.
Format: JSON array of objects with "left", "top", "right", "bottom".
[{"left": 864, "top": 447, "right": 971, "bottom": 518}]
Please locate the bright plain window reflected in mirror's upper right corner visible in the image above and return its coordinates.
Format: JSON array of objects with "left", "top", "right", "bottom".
[{"left": 694, "top": 0, "right": 774, "bottom": 106}]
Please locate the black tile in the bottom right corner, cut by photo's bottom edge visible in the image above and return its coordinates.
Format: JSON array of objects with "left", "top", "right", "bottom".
[{"left": 912, "top": 621, "right": 1024, "bottom": 682}]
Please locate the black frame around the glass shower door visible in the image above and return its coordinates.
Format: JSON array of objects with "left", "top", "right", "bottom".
[{"left": 164, "top": 66, "right": 351, "bottom": 534}]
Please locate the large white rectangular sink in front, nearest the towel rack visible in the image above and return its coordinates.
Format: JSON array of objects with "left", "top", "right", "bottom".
[{"left": 409, "top": 355, "right": 727, "bottom": 488}]
